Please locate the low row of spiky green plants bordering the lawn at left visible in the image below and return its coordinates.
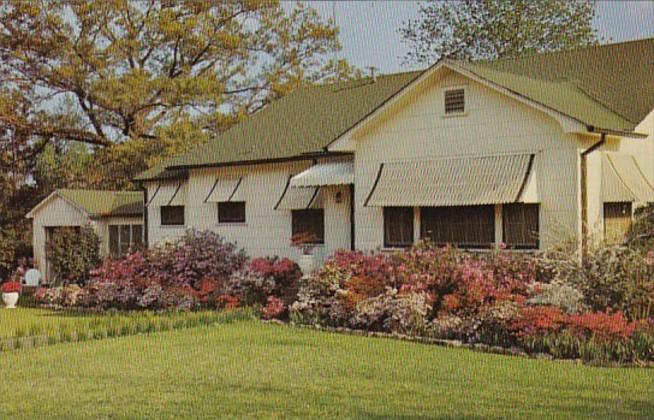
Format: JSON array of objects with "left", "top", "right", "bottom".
[{"left": 0, "top": 309, "right": 255, "bottom": 352}]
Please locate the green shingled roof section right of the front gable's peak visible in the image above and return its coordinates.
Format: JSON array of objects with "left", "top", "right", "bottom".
[{"left": 453, "top": 38, "right": 654, "bottom": 131}]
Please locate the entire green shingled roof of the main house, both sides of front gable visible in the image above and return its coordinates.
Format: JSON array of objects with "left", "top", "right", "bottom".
[{"left": 136, "top": 39, "right": 654, "bottom": 180}]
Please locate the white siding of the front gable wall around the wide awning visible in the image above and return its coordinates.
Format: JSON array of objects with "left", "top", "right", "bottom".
[{"left": 354, "top": 72, "right": 580, "bottom": 250}]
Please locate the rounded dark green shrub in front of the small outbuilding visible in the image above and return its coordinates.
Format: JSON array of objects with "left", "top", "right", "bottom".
[{"left": 46, "top": 226, "right": 101, "bottom": 284}]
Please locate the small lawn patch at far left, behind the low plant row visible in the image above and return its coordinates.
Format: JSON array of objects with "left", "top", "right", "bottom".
[{"left": 0, "top": 306, "right": 88, "bottom": 338}]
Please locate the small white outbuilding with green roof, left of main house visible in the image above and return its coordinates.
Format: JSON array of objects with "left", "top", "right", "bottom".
[{"left": 27, "top": 189, "right": 144, "bottom": 283}]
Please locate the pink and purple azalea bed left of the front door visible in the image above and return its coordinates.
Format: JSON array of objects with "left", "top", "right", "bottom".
[{"left": 35, "top": 230, "right": 302, "bottom": 318}]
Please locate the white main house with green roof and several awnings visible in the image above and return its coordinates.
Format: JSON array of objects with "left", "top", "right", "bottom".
[{"left": 32, "top": 39, "right": 654, "bottom": 270}]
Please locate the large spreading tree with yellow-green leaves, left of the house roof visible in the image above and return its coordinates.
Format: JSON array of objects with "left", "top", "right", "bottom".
[{"left": 0, "top": 0, "right": 350, "bottom": 182}]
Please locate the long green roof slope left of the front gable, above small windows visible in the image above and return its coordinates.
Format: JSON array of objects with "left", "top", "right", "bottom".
[{"left": 136, "top": 71, "right": 421, "bottom": 180}]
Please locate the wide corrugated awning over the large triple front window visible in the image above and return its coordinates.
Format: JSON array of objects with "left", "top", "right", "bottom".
[{"left": 365, "top": 154, "right": 538, "bottom": 207}]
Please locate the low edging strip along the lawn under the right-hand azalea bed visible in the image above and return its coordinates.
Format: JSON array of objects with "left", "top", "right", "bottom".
[{"left": 262, "top": 319, "right": 654, "bottom": 368}]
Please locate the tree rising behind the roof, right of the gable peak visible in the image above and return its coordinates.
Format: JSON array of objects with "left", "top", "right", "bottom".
[{"left": 399, "top": 0, "right": 598, "bottom": 64}]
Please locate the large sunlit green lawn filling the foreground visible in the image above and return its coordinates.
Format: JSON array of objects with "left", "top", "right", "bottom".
[{"left": 0, "top": 321, "right": 654, "bottom": 419}]
